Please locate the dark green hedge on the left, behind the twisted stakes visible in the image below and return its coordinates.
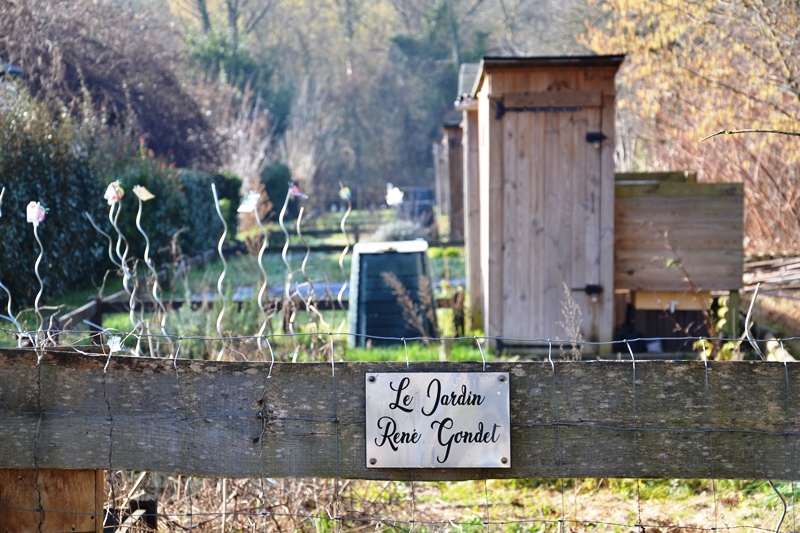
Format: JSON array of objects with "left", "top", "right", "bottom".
[{"left": 0, "top": 82, "right": 240, "bottom": 304}]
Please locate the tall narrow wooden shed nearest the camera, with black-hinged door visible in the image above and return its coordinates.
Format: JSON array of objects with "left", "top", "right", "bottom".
[{"left": 466, "top": 56, "right": 624, "bottom": 350}]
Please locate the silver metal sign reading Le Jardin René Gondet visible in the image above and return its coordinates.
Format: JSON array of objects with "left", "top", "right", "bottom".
[{"left": 365, "top": 372, "right": 511, "bottom": 468}]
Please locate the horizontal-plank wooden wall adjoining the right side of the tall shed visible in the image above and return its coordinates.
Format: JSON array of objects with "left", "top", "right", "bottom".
[{"left": 614, "top": 173, "right": 744, "bottom": 291}]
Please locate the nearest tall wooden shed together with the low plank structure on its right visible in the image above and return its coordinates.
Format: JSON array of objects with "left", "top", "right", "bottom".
[{"left": 456, "top": 56, "right": 744, "bottom": 347}]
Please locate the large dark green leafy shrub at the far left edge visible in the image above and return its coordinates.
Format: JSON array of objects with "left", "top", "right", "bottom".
[{"left": 0, "top": 82, "right": 106, "bottom": 305}]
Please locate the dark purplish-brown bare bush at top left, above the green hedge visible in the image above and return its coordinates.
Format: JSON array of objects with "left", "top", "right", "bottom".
[{"left": 0, "top": 0, "right": 218, "bottom": 166}]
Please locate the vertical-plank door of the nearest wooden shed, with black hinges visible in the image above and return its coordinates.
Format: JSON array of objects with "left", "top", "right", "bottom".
[{"left": 502, "top": 106, "right": 613, "bottom": 340}]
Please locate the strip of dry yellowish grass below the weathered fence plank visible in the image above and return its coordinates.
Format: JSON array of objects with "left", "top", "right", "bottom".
[{"left": 103, "top": 473, "right": 796, "bottom": 533}]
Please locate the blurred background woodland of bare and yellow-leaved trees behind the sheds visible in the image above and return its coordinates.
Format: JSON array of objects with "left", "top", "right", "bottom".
[{"left": 0, "top": 0, "right": 800, "bottom": 254}]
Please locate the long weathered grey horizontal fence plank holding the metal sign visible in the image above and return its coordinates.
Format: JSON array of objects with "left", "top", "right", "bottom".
[{"left": 0, "top": 350, "right": 800, "bottom": 480}]
